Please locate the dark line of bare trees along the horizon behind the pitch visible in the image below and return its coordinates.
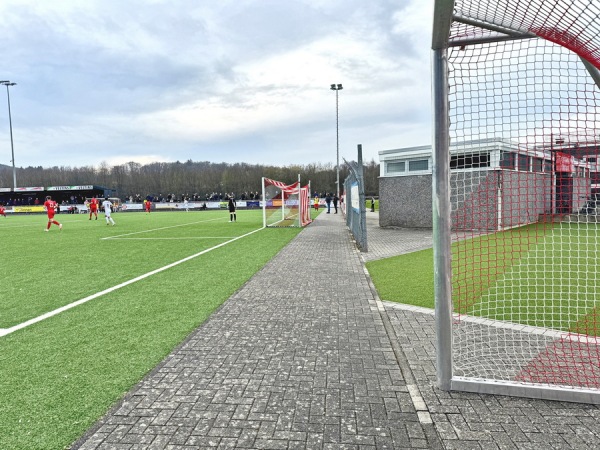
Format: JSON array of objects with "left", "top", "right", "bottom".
[{"left": 0, "top": 160, "right": 379, "bottom": 197}]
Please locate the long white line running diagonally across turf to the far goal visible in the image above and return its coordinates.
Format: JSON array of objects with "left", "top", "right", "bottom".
[{"left": 0, "top": 227, "right": 264, "bottom": 337}]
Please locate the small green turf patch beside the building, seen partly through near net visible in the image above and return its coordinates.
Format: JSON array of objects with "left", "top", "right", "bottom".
[{"left": 367, "top": 223, "right": 600, "bottom": 336}]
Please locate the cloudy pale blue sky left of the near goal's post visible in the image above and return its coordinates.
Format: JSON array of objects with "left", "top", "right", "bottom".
[{"left": 0, "top": 0, "right": 433, "bottom": 171}]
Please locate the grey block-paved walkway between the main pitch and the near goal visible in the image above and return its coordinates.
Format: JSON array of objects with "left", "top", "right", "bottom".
[{"left": 74, "top": 213, "right": 600, "bottom": 450}]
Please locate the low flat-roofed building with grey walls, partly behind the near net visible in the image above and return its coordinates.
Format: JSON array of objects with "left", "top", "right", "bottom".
[{"left": 379, "top": 139, "right": 591, "bottom": 230}]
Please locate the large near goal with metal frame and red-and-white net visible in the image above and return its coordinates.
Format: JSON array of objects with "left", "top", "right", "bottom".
[{"left": 432, "top": 0, "right": 600, "bottom": 403}]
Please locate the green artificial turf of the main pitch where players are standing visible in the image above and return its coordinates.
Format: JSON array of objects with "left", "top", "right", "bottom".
[{"left": 0, "top": 211, "right": 300, "bottom": 449}]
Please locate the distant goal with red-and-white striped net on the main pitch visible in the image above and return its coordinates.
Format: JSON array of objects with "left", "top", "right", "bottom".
[{"left": 262, "top": 177, "right": 311, "bottom": 227}]
